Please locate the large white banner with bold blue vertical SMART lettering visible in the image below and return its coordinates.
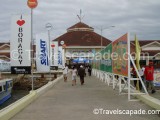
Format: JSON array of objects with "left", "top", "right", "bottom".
[{"left": 36, "top": 33, "right": 50, "bottom": 72}]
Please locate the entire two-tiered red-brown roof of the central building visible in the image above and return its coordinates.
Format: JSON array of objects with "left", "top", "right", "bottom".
[{"left": 55, "top": 22, "right": 111, "bottom": 46}]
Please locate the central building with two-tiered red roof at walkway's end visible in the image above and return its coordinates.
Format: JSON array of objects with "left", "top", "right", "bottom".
[{"left": 54, "top": 22, "right": 112, "bottom": 64}]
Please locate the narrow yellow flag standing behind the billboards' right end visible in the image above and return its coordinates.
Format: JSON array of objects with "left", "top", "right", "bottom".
[{"left": 135, "top": 35, "right": 141, "bottom": 70}]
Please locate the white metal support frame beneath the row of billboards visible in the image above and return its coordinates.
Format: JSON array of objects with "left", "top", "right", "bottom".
[{"left": 92, "top": 69, "right": 147, "bottom": 101}]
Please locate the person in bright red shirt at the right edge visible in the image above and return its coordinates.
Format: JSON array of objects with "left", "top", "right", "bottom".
[{"left": 144, "top": 62, "right": 156, "bottom": 94}]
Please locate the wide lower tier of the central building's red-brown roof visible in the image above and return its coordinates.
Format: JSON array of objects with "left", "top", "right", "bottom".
[{"left": 55, "top": 31, "right": 111, "bottom": 46}]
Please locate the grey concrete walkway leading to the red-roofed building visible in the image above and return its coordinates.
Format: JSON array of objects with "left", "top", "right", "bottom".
[{"left": 11, "top": 76, "right": 160, "bottom": 120}]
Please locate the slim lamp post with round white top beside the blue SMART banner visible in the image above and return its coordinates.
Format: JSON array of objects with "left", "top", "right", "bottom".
[{"left": 45, "top": 23, "right": 53, "bottom": 80}]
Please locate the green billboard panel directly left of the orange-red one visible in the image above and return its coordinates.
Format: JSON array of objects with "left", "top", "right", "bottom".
[{"left": 100, "top": 44, "right": 112, "bottom": 73}]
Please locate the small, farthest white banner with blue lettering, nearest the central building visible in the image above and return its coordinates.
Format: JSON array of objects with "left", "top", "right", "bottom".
[{"left": 58, "top": 46, "right": 65, "bottom": 68}]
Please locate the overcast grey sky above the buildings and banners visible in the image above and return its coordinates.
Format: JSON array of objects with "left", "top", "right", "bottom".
[{"left": 0, "top": 0, "right": 160, "bottom": 42}]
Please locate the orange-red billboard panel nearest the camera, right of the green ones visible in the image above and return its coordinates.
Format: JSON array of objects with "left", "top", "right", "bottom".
[{"left": 112, "top": 34, "right": 128, "bottom": 77}]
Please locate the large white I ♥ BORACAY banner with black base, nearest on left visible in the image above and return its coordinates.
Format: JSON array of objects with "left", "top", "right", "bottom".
[{"left": 10, "top": 15, "right": 31, "bottom": 74}]
